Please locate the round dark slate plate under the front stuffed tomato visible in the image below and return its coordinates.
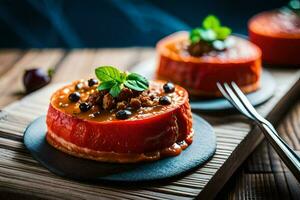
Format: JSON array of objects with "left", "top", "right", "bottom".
[{"left": 24, "top": 115, "right": 216, "bottom": 182}]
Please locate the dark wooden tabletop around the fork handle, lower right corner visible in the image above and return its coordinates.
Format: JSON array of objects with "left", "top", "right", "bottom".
[{"left": 218, "top": 101, "right": 300, "bottom": 199}]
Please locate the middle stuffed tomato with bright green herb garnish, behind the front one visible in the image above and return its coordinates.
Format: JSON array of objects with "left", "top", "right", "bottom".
[{"left": 156, "top": 16, "right": 261, "bottom": 97}]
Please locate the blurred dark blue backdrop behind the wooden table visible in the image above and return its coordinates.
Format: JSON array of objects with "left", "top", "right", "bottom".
[{"left": 0, "top": 0, "right": 288, "bottom": 48}]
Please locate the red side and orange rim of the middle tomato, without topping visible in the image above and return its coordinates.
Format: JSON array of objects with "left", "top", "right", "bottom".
[{"left": 156, "top": 32, "right": 262, "bottom": 97}]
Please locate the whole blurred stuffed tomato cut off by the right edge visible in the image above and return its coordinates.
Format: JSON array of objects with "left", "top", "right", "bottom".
[{"left": 248, "top": 10, "right": 300, "bottom": 65}]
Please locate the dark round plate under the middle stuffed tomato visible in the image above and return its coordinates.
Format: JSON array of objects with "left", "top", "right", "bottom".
[{"left": 190, "top": 70, "right": 276, "bottom": 112}]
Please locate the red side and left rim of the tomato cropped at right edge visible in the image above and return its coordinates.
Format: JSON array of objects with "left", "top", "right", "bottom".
[{"left": 248, "top": 11, "right": 300, "bottom": 66}]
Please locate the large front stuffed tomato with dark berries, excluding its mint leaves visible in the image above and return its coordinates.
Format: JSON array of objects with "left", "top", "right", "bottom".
[{"left": 47, "top": 66, "right": 193, "bottom": 163}]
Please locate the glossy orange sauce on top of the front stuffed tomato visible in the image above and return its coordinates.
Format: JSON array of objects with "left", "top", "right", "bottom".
[{"left": 51, "top": 80, "right": 186, "bottom": 122}]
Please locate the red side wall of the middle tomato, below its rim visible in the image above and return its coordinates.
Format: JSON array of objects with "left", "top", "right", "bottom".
[{"left": 157, "top": 56, "right": 261, "bottom": 97}]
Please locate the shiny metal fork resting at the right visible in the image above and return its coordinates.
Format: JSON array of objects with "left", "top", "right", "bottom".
[{"left": 217, "top": 82, "right": 300, "bottom": 182}]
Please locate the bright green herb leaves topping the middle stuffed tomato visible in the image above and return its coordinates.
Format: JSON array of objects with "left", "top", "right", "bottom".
[{"left": 190, "top": 15, "right": 231, "bottom": 44}]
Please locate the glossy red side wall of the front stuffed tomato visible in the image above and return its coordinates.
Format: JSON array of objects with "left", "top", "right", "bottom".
[{"left": 46, "top": 86, "right": 192, "bottom": 153}]
